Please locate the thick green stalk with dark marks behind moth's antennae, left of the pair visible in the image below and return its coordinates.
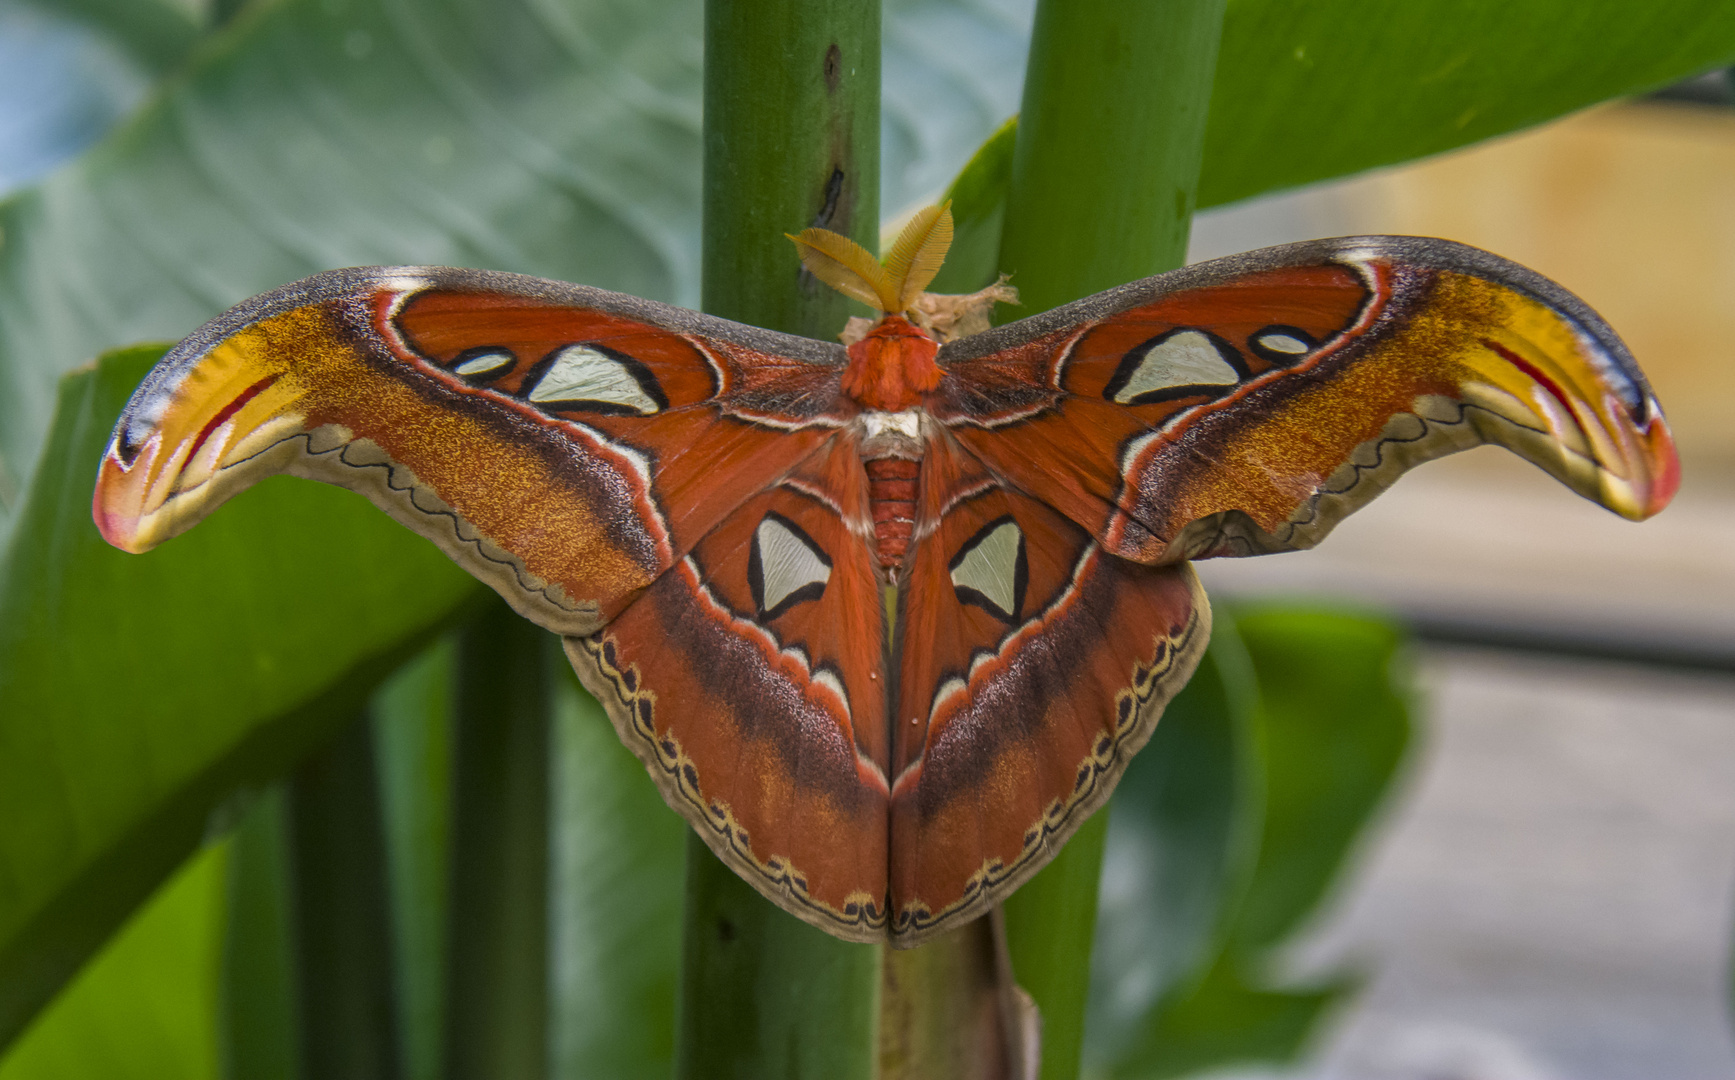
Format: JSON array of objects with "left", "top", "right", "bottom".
[{"left": 675, "top": 0, "right": 880, "bottom": 1080}]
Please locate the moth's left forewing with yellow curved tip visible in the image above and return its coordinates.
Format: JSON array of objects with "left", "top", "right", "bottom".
[{"left": 95, "top": 267, "right": 854, "bottom": 634}]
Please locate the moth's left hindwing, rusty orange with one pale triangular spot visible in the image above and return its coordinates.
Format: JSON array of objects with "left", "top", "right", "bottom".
[{"left": 567, "top": 438, "right": 888, "bottom": 941}]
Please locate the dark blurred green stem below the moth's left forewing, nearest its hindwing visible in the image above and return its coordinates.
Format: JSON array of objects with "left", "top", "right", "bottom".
[{"left": 444, "top": 601, "right": 553, "bottom": 1080}]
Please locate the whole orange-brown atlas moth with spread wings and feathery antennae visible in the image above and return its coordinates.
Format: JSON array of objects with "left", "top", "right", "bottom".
[{"left": 94, "top": 207, "right": 1679, "bottom": 946}]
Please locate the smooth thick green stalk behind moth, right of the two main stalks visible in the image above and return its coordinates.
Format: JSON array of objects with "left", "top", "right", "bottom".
[{"left": 999, "top": 0, "right": 1223, "bottom": 1080}]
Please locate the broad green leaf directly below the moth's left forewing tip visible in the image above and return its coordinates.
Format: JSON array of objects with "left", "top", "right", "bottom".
[{"left": 0, "top": 349, "right": 479, "bottom": 1040}]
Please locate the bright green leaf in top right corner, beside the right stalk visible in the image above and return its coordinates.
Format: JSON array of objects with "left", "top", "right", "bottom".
[{"left": 1199, "top": 0, "right": 1735, "bottom": 207}]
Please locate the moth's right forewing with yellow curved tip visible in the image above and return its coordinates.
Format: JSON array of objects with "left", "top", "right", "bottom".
[{"left": 930, "top": 236, "right": 1678, "bottom": 563}]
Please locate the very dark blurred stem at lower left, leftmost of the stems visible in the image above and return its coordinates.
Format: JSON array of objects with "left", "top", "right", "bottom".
[{"left": 288, "top": 717, "right": 401, "bottom": 1080}]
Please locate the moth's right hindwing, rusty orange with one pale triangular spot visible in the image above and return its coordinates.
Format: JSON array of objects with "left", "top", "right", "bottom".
[{"left": 890, "top": 432, "right": 1211, "bottom": 943}]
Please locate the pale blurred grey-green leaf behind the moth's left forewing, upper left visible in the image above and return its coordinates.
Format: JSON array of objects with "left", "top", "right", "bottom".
[{"left": 0, "top": 0, "right": 699, "bottom": 534}]
